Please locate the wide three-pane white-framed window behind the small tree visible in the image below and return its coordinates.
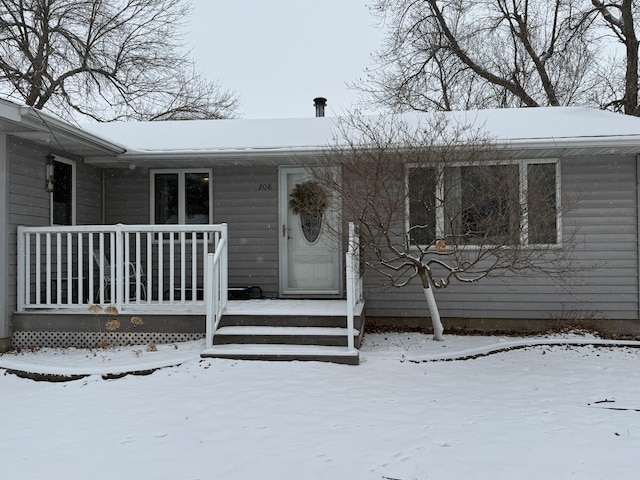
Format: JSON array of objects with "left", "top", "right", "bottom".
[{"left": 407, "top": 161, "right": 558, "bottom": 245}]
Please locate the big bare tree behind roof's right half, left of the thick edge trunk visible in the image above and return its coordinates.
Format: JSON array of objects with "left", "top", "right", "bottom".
[{"left": 361, "top": 0, "right": 608, "bottom": 110}]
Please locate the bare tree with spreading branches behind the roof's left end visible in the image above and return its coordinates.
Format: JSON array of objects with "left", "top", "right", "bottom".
[{"left": 0, "top": 0, "right": 238, "bottom": 121}]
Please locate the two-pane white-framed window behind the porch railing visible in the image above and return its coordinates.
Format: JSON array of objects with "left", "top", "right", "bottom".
[{"left": 151, "top": 170, "right": 212, "bottom": 225}]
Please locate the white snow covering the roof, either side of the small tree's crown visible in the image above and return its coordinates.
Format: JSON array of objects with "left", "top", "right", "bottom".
[{"left": 82, "top": 107, "right": 640, "bottom": 154}]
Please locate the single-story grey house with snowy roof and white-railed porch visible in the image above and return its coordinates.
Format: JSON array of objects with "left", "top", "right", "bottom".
[{"left": 0, "top": 95, "right": 640, "bottom": 361}]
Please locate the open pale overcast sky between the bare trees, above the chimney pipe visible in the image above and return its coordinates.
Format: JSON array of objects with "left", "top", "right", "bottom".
[{"left": 188, "top": 0, "right": 382, "bottom": 118}]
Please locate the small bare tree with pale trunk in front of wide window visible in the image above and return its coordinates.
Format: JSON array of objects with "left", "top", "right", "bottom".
[{"left": 310, "top": 114, "right": 576, "bottom": 340}]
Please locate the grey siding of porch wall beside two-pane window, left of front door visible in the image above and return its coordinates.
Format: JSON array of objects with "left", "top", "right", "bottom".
[{"left": 106, "top": 165, "right": 278, "bottom": 296}]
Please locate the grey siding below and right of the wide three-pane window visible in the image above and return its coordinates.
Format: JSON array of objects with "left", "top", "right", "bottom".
[{"left": 365, "top": 156, "right": 638, "bottom": 319}]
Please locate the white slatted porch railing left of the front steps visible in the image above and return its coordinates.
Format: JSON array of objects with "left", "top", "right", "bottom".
[{"left": 17, "top": 224, "right": 227, "bottom": 312}]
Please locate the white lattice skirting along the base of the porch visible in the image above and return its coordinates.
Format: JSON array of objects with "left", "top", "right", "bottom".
[{"left": 12, "top": 331, "right": 204, "bottom": 350}]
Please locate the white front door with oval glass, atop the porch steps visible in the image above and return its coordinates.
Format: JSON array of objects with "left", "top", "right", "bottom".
[{"left": 279, "top": 167, "right": 342, "bottom": 297}]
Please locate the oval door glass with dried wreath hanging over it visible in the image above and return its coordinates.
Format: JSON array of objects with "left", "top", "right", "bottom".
[{"left": 289, "top": 180, "right": 329, "bottom": 243}]
